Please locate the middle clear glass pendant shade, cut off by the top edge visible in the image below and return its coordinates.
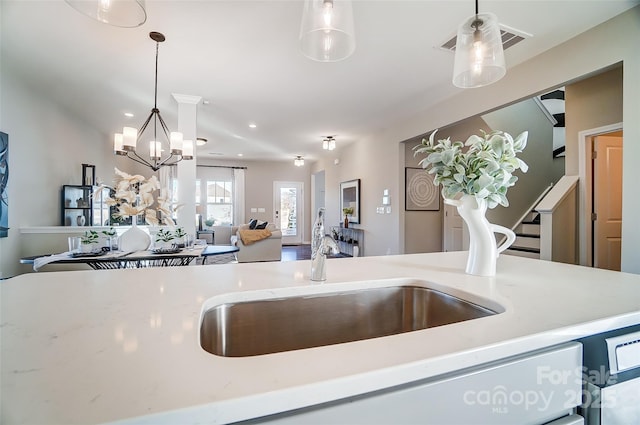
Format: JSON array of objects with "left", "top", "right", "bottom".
[{"left": 300, "top": 0, "right": 356, "bottom": 62}]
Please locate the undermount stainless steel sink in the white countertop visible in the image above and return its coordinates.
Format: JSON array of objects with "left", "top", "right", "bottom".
[{"left": 200, "top": 286, "right": 497, "bottom": 357}]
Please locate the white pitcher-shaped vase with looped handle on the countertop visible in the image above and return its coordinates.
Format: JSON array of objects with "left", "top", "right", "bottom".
[{"left": 444, "top": 195, "right": 516, "bottom": 276}]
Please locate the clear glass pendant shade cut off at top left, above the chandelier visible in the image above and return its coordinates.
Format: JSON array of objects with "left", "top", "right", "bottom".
[{"left": 65, "top": 0, "right": 147, "bottom": 28}]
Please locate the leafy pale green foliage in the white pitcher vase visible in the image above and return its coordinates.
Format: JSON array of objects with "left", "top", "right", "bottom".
[{"left": 414, "top": 130, "right": 529, "bottom": 208}]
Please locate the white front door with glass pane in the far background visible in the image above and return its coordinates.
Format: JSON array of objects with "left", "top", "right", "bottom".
[{"left": 273, "top": 182, "right": 304, "bottom": 244}]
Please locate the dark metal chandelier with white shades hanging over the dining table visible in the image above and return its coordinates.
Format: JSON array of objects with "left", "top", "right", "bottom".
[{"left": 113, "top": 31, "right": 193, "bottom": 171}]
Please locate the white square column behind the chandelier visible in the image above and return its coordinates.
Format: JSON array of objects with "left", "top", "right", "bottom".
[{"left": 172, "top": 93, "right": 202, "bottom": 235}]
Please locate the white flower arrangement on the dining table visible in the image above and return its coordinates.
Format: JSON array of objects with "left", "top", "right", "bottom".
[{"left": 96, "top": 168, "right": 180, "bottom": 226}]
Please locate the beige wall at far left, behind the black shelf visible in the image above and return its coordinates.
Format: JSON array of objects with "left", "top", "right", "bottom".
[{"left": 0, "top": 63, "right": 115, "bottom": 277}]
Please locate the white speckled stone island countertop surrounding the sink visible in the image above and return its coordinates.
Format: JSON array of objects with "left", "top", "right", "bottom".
[{"left": 0, "top": 252, "right": 640, "bottom": 424}]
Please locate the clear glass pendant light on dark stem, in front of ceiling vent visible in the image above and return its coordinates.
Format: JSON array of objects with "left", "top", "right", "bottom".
[{"left": 453, "top": 0, "right": 507, "bottom": 88}]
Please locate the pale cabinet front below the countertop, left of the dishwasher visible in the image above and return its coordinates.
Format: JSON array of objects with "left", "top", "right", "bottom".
[{"left": 251, "top": 342, "right": 582, "bottom": 425}]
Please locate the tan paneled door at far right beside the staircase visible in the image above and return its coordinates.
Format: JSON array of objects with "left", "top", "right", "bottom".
[{"left": 593, "top": 136, "right": 622, "bottom": 271}]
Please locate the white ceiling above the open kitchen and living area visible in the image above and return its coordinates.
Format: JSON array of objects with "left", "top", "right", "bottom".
[{"left": 0, "top": 0, "right": 639, "bottom": 160}]
